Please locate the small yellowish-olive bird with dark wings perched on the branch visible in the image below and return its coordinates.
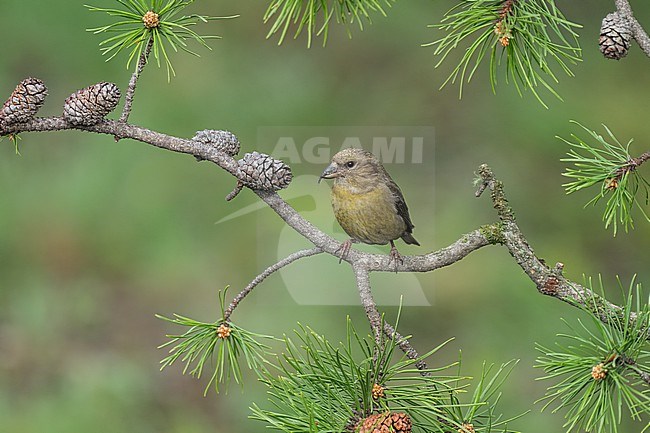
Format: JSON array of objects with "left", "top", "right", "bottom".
[{"left": 318, "top": 148, "right": 420, "bottom": 266}]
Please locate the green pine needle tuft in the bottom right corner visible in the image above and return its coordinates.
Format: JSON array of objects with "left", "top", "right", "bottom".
[{"left": 537, "top": 278, "right": 650, "bottom": 433}]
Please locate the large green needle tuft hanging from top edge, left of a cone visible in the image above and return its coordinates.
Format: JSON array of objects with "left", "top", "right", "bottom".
[{"left": 424, "top": 0, "right": 581, "bottom": 107}]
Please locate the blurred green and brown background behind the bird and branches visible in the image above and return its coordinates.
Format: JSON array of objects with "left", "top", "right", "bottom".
[{"left": 0, "top": 0, "right": 650, "bottom": 433}]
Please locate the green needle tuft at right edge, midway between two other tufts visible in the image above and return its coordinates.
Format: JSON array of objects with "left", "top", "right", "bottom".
[{"left": 558, "top": 122, "right": 650, "bottom": 235}]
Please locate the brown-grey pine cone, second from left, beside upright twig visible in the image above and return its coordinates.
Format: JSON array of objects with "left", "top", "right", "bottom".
[{"left": 63, "top": 82, "right": 122, "bottom": 126}]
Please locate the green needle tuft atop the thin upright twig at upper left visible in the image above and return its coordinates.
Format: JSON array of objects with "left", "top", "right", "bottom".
[{"left": 85, "top": 0, "right": 235, "bottom": 80}]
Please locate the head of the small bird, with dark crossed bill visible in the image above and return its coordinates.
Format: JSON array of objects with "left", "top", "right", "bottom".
[{"left": 318, "top": 147, "right": 384, "bottom": 184}]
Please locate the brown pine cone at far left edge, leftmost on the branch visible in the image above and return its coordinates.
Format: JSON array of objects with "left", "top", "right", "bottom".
[{"left": 0, "top": 78, "right": 47, "bottom": 126}]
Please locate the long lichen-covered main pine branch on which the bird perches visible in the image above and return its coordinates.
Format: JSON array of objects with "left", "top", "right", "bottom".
[{"left": 0, "top": 117, "right": 650, "bottom": 338}]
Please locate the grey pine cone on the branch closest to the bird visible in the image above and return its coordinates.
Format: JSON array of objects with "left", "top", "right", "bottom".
[{"left": 237, "top": 152, "right": 293, "bottom": 191}]
